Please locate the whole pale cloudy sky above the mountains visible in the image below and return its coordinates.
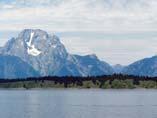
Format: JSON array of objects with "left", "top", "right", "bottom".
[{"left": 0, "top": 0, "right": 157, "bottom": 65}]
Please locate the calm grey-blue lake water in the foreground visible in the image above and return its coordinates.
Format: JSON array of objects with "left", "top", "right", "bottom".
[{"left": 0, "top": 89, "right": 157, "bottom": 118}]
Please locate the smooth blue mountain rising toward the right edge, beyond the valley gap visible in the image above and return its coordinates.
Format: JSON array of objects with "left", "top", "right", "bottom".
[{"left": 122, "top": 56, "right": 157, "bottom": 77}]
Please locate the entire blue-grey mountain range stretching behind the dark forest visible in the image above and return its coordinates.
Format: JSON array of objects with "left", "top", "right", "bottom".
[{"left": 0, "top": 29, "right": 157, "bottom": 78}]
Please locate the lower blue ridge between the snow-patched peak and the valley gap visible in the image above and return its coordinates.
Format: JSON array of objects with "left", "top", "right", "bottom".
[{"left": 56, "top": 55, "right": 113, "bottom": 76}]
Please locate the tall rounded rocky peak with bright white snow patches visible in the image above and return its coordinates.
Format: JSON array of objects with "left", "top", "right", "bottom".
[{"left": 2, "top": 29, "right": 68, "bottom": 76}]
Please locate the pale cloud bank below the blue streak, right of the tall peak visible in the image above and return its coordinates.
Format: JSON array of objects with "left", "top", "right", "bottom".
[{"left": 60, "top": 33, "right": 157, "bottom": 65}]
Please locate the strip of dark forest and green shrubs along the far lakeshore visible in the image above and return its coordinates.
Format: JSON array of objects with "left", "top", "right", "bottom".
[{"left": 0, "top": 74, "right": 157, "bottom": 89}]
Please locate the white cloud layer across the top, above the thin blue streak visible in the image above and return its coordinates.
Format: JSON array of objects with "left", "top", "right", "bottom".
[{"left": 0, "top": 0, "right": 157, "bottom": 32}]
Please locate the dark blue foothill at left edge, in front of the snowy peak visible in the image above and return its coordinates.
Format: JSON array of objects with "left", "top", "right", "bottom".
[{"left": 0, "top": 55, "right": 39, "bottom": 79}]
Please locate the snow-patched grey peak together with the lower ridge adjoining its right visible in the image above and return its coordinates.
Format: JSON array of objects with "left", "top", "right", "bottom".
[{"left": 1, "top": 29, "right": 113, "bottom": 76}]
